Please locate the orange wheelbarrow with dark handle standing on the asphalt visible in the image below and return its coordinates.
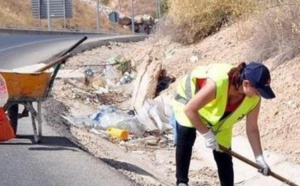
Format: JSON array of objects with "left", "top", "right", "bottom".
[{"left": 0, "top": 36, "right": 87, "bottom": 143}]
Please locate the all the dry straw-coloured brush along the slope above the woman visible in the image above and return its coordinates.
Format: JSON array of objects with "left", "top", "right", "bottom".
[{"left": 156, "top": 0, "right": 300, "bottom": 62}]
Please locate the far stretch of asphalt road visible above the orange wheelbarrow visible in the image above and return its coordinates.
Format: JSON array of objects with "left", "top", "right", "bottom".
[{"left": 0, "top": 33, "right": 89, "bottom": 69}]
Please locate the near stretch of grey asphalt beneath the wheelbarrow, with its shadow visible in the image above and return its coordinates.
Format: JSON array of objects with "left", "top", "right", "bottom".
[{"left": 0, "top": 118, "right": 135, "bottom": 186}]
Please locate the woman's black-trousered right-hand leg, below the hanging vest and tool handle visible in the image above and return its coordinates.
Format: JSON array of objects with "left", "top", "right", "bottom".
[{"left": 213, "top": 150, "right": 234, "bottom": 186}]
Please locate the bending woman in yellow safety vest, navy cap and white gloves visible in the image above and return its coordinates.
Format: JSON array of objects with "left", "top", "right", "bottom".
[{"left": 172, "top": 62, "right": 275, "bottom": 186}]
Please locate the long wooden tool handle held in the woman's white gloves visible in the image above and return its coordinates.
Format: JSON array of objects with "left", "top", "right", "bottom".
[{"left": 219, "top": 145, "right": 299, "bottom": 186}]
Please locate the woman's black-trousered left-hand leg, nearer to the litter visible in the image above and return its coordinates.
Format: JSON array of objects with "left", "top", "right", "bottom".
[{"left": 176, "top": 122, "right": 196, "bottom": 184}]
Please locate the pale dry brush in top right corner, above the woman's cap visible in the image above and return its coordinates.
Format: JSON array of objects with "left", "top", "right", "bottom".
[{"left": 241, "top": 0, "right": 300, "bottom": 63}]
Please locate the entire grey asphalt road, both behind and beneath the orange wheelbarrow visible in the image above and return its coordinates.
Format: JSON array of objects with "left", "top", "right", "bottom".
[{"left": 0, "top": 34, "right": 135, "bottom": 186}]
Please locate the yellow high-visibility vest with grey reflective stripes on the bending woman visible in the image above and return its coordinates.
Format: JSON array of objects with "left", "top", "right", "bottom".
[{"left": 172, "top": 63, "right": 260, "bottom": 148}]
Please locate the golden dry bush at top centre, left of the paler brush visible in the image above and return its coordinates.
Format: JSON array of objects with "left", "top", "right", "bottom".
[{"left": 165, "top": 0, "right": 256, "bottom": 44}]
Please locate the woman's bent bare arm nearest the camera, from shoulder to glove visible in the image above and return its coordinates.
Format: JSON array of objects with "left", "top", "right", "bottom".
[{"left": 184, "top": 79, "right": 216, "bottom": 134}]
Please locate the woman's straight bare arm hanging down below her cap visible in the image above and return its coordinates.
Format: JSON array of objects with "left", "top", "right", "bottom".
[{"left": 246, "top": 101, "right": 262, "bottom": 157}]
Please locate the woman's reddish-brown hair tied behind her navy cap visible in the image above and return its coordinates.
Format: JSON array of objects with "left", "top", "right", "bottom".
[{"left": 228, "top": 62, "right": 246, "bottom": 90}]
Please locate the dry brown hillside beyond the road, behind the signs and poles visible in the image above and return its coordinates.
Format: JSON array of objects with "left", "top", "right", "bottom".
[{"left": 0, "top": 0, "right": 156, "bottom": 31}]
